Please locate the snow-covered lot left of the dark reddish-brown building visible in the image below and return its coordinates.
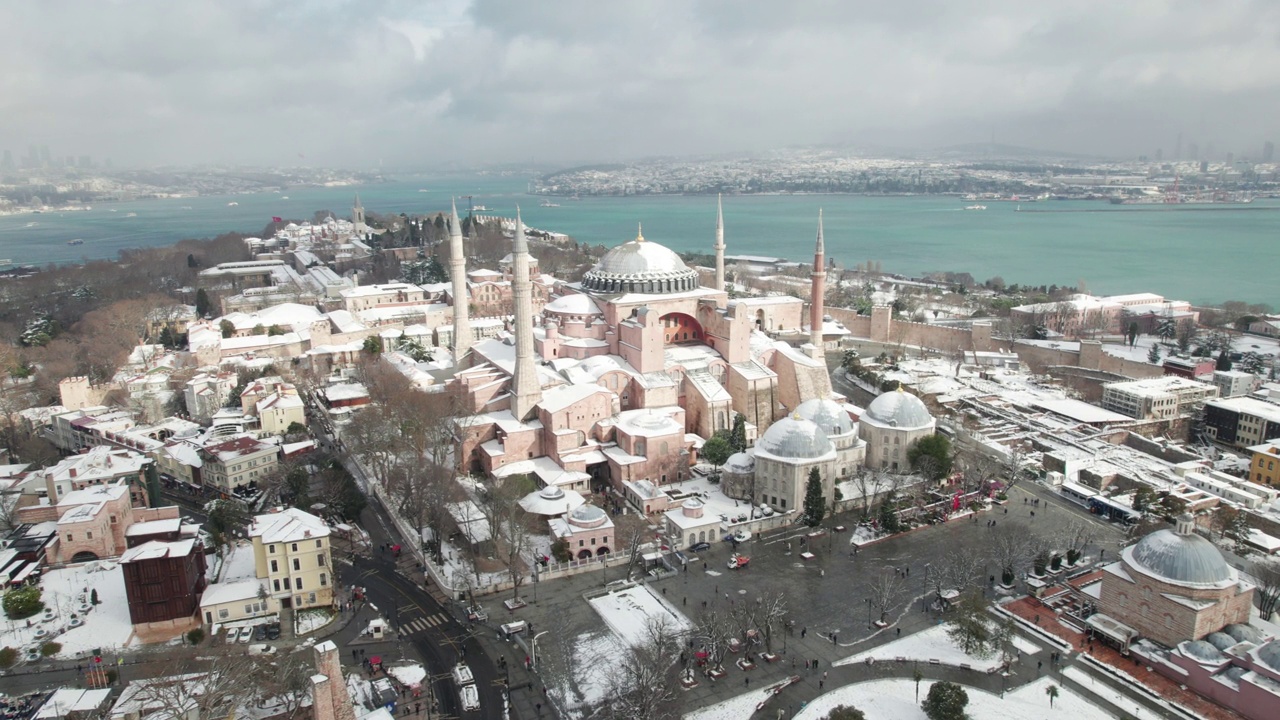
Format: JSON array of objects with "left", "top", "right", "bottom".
[{"left": 0, "top": 562, "right": 133, "bottom": 657}]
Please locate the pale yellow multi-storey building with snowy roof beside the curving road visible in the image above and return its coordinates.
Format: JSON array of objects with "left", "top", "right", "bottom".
[{"left": 248, "top": 507, "right": 334, "bottom": 610}]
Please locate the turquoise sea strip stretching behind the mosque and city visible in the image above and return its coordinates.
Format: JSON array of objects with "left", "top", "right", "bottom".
[{"left": 0, "top": 176, "right": 1280, "bottom": 306}]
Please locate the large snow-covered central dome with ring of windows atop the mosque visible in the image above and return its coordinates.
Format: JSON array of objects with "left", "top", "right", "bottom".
[{"left": 582, "top": 222, "right": 699, "bottom": 295}]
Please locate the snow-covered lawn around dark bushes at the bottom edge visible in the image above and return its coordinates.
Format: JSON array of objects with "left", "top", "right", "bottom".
[{"left": 793, "top": 678, "right": 1115, "bottom": 720}]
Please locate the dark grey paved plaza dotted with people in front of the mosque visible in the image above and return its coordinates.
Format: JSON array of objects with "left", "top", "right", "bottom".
[{"left": 499, "top": 483, "right": 1124, "bottom": 710}]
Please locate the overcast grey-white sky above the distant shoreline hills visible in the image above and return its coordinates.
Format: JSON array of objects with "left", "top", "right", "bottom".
[{"left": 0, "top": 0, "right": 1280, "bottom": 169}]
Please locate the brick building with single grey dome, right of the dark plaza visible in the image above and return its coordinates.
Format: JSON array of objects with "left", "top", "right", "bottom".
[{"left": 1091, "top": 515, "right": 1253, "bottom": 647}]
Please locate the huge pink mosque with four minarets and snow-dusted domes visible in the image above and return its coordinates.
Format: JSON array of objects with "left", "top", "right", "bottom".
[{"left": 449, "top": 196, "right": 933, "bottom": 520}]
